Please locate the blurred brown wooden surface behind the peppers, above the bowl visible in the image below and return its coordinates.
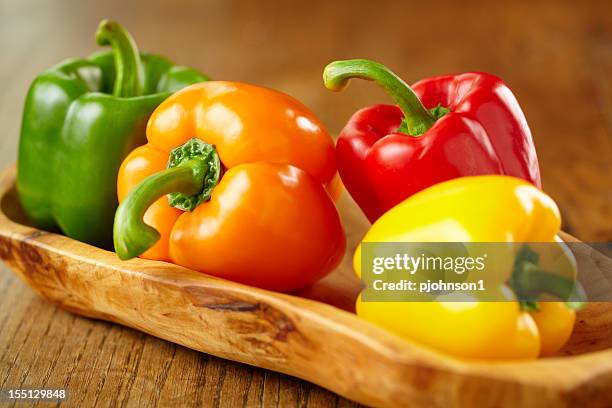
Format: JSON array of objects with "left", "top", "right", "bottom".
[{"left": 0, "top": 0, "right": 612, "bottom": 241}]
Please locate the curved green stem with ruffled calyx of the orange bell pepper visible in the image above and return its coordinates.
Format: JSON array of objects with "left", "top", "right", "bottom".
[{"left": 113, "top": 139, "right": 221, "bottom": 260}]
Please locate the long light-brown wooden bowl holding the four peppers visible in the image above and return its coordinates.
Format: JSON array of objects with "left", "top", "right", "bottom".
[{"left": 0, "top": 167, "right": 612, "bottom": 407}]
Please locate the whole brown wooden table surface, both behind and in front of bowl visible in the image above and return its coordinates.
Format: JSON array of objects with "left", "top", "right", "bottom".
[{"left": 0, "top": 0, "right": 612, "bottom": 407}]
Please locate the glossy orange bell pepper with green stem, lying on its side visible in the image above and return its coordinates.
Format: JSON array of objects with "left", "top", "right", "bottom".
[{"left": 114, "top": 81, "right": 346, "bottom": 291}]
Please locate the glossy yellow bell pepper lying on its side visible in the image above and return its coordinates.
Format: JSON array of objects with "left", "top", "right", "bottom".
[{"left": 354, "top": 176, "right": 582, "bottom": 359}]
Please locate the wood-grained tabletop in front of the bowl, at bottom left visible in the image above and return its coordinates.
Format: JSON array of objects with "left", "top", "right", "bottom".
[{"left": 0, "top": 273, "right": 355, "bottom": 407}]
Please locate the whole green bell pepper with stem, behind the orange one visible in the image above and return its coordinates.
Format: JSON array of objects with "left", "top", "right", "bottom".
[{"left": 17, "top": 21, "right": 207, "bottom": 248}]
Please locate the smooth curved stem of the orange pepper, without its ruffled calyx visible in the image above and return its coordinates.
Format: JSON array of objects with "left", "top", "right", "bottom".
[{"left": 113, "top": 159, "right": 206, "bottom": 260}]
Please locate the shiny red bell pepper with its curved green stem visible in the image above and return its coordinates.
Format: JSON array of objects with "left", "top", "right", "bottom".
[{"left": 323, "top": 60, "right": 541, "bottom": 222}]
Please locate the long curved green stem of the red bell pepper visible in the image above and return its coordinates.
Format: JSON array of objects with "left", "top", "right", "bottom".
[{"left": 323, "top": 59, "right": 438, "bottom": 136}]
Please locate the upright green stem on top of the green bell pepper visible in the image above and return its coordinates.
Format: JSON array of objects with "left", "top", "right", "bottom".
[{"left": 96, "top": 20, "right": 142, "bottom": 98}]
